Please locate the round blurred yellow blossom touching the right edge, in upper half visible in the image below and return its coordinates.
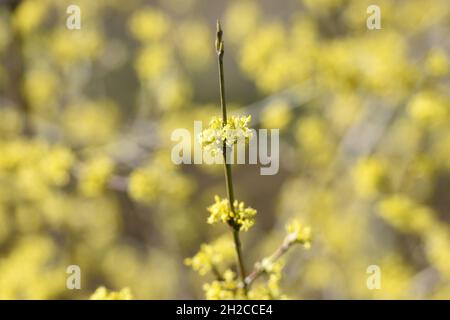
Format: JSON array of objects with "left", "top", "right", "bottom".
[{"left": 407, "top": 91, "right": 450, "bottom": 125}]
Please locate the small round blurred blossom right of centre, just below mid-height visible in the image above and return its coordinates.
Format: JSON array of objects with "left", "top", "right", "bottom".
[{"left": 352, "top": 157, "right": 388, "bottom": 198}]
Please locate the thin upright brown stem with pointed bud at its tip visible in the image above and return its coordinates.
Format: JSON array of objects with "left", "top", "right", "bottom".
[{"left": 216, "top": 21, "right": 247, "bottom": 295}]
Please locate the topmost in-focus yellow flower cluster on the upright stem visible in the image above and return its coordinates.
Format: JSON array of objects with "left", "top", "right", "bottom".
[{"left": 199, "top": 116, "right": 253, "bottom": 155}]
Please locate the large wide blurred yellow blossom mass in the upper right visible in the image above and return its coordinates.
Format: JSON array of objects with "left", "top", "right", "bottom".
[{"left": 318, "top": 32, "right": 418, "bottom": 102}]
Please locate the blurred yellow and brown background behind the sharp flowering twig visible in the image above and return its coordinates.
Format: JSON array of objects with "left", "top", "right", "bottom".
[{"left": 0, "top": 0, "right": 450, "bottom": 299}]
